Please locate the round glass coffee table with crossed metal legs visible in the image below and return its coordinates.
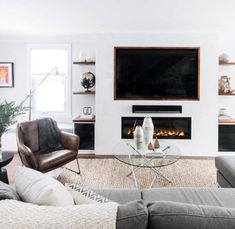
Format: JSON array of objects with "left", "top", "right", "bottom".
[{"left": 113, "top": 140, "right": 181, "bottom": 188}]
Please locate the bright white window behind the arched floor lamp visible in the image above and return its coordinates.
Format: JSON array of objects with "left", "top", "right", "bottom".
[{"left": 30, "top": 45, "right": 71, "bottom": 122}]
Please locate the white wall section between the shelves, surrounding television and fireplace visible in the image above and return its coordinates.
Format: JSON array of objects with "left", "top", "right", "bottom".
[{"left": 96, "top": 33, "right": 218, "bottom": 155}]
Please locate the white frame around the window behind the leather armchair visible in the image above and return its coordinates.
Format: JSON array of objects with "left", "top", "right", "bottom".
[{"left": 27, "top": 44, "right": 72, "bottom": 123}]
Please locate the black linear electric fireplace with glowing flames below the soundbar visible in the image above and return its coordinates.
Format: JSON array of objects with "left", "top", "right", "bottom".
[{"left": 122, "top": 117, "right": 191, "bottom": 139}]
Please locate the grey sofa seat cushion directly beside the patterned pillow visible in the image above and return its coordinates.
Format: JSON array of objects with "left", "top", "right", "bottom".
[{"left": 93, "top": 188, "right": 141, "bottom": 204}]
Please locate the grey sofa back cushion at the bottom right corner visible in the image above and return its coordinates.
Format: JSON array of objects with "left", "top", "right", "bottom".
[{"left": 148, "top": 201, "right": 235, "bottom": 229}]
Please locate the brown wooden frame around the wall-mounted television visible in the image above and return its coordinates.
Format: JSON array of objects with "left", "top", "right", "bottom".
[{"left": 114, "top": 46, "right": 200, "bottom": 101}]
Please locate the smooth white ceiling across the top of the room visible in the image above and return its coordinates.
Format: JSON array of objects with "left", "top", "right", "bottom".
[{"left": 0, "top": 0, "right": 235, "bottom": 36}]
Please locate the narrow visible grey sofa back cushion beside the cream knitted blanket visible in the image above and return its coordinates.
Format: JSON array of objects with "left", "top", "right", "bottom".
[{"left": 116, "top": 200, "right": 148, "bottom": 229}]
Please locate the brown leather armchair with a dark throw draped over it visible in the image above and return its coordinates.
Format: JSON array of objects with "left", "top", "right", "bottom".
[{"left": 16, "top": 120, "right": 80, "bottom": 174}]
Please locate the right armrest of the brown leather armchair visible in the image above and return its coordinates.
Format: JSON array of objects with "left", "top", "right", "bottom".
[{"left": 61, "top": 131, "right": 80, "bottom": 151}]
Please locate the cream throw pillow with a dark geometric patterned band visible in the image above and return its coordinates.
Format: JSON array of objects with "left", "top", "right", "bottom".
[{"left": 65, "top": 183, "right": 112, "bottom": 204}]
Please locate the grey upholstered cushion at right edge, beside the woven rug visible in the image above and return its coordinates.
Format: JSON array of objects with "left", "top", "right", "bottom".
[{"left": 215, "top": 155, "right": 235, "bottom": 187}]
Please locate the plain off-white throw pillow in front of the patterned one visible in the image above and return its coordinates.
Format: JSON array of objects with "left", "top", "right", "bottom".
[{"left": 15, "top": 167, "right": 74, "bottom": 206}]
